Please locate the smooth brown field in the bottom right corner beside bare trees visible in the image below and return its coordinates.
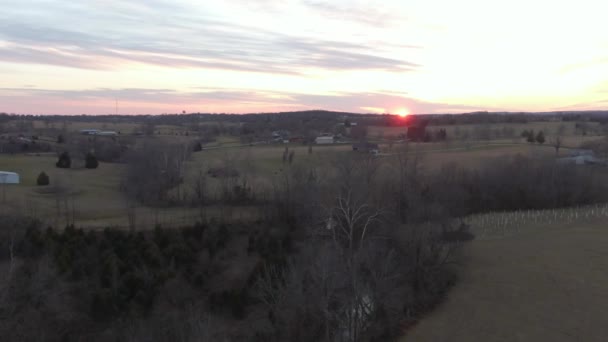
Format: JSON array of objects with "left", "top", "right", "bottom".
[{"left": 402, "top": 212, "right": 608, "bottom": 342}]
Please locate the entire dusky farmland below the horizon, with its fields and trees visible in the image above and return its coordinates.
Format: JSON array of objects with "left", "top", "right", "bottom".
[{"left": 0, "top": 116, "right": 608, "bottom": 341}]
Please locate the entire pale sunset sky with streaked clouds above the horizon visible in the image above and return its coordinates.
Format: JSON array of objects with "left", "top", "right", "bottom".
[{"left": 0, "top": 0, "right": 608, "bottom": 114}]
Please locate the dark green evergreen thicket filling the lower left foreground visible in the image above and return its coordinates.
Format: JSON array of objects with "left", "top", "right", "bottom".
[{"left": 0, "top": 217, "right": 292, "bottom": 341}]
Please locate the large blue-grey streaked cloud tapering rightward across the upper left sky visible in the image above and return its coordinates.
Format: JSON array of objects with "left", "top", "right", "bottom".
[{"left": 0, "top": 0, "right": 418, "bottom": 74}]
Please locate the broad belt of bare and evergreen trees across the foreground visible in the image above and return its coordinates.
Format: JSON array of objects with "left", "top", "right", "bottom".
[{"left": 0, "top": 148, "right": 608, "bottom": 342}]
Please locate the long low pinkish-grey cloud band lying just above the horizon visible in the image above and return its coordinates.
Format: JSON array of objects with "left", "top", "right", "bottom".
[{"left": 0, "top": 88, "right": 484, "bottom": 114}]
